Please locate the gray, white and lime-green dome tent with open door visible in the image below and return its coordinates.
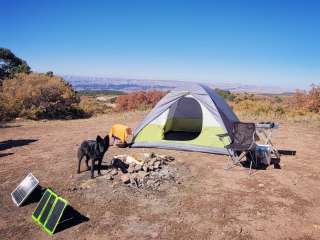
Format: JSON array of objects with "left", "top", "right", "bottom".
[{"left": 132, "top": 83, "right": 239, "bottom": 154}]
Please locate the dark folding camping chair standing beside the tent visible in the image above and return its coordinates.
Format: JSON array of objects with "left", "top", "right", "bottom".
[{"left": 217, "top": 122, "right": 257, "bottom": 175}]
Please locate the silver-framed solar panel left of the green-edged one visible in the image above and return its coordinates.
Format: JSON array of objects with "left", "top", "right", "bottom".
[{"left": 11, "top": 173, "right": 39, "bottom": 206}]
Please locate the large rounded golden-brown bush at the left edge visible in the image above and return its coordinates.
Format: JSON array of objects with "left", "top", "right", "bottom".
[{"left": 0, "top": 73, "right": 85, "bottom": 120}]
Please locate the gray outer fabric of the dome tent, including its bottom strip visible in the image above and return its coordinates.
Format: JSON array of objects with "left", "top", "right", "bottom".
[{"left": 132, "top": 83, "right": 239, "bottom": 154}]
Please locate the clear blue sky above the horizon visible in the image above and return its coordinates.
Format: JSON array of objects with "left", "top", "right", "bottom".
[{"left": 0, "top": 0, "right": 320, "bottom": 89}]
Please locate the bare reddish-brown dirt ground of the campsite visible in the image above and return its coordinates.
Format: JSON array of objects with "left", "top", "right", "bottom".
[{"left": 0, "top": 112, "right": 320, "bottom": 240}]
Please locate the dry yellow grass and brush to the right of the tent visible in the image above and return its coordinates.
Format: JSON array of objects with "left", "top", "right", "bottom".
[{"left": 228, "top": 86, "right": 320, "bottom": 123}]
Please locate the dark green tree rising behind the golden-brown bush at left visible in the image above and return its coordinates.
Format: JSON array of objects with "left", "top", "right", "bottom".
[{"left": 0, "top": 48, "right": 31, "bottom": 80}]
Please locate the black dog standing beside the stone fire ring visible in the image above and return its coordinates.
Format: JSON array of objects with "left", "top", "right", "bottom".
[{"left": 77, "top": 135, "right": 109, "bottom": 178}]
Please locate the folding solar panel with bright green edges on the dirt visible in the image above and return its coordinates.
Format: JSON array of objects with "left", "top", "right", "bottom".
[{"left": 32, "top": 189, "right": 68, "bottom": 235}]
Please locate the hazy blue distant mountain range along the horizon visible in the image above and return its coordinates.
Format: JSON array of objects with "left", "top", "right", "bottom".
[{"left": 62, "top": 75, "right": 290, "bottom": 94}]
